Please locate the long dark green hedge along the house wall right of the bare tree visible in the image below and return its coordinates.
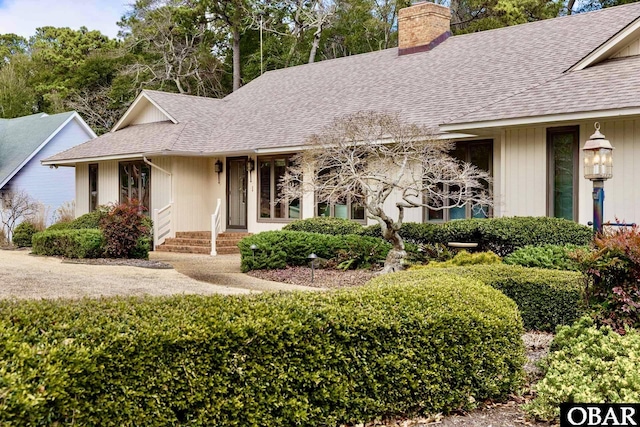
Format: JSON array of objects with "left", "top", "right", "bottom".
[{"left": 363, "top": 217, "right": 593, "bottom": 256}]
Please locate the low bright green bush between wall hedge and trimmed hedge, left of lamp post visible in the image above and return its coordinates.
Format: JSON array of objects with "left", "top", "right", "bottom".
[{"left": 503, "top": 245, "right": 586, "bottom": 271}]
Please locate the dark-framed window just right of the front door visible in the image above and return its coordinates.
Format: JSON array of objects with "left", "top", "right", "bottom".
[{"left": 258, "top": 156, "right": 300, "bottom": 220}]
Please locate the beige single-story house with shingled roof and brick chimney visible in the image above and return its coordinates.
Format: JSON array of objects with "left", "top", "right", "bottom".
[{"left": 43, "top": 3, "right": 640, "bottom": 253}]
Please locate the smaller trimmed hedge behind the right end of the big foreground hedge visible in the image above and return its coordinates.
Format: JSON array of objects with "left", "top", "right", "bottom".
[{"left": 406, "top": 264, "right": 585, "bottom": 331}]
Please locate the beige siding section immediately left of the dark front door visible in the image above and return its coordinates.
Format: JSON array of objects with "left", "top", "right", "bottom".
[{"left": 172, "top": 157, "right": 215, "bottom": 231}]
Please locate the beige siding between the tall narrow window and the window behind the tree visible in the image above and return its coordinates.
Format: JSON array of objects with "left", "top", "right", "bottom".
[{"left": 502, "top": 127, "right": 547, "bottom": 216}]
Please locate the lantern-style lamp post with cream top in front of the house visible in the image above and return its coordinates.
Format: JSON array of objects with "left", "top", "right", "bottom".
[{"left": 582, "top": 122, "right": 613, "bottom": 233}]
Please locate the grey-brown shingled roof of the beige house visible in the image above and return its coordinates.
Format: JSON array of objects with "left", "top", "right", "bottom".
[{"left": 42, "top": 3, "right": 640, "bottom": 163}]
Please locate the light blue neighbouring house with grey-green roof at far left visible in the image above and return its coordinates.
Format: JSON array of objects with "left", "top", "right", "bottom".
[{"left": 0, "top": 111, "right": 96, "bottom": 227}]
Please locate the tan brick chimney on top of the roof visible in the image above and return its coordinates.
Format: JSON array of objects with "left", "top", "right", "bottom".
[{"left": 398, "top": 2, "right": 451, "bottom": 55}]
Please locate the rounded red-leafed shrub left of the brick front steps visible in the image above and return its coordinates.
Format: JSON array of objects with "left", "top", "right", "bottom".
[{"left": 100, "top": 200, "right": 150, "bottom": 258}]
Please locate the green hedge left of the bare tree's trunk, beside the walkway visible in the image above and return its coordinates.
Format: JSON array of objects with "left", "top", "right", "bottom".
[{"left": 238, "top": 231, "right": 391, "bottom": 272}]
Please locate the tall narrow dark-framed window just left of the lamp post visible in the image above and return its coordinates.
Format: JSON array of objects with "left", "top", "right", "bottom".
[{"left": 547, "top": 126, "right": 580, "bottom": 220}]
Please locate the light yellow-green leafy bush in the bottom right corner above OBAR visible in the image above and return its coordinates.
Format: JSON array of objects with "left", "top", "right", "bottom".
[{"left": 525, "top": 318, "right": 640, "bottom": 421}]
